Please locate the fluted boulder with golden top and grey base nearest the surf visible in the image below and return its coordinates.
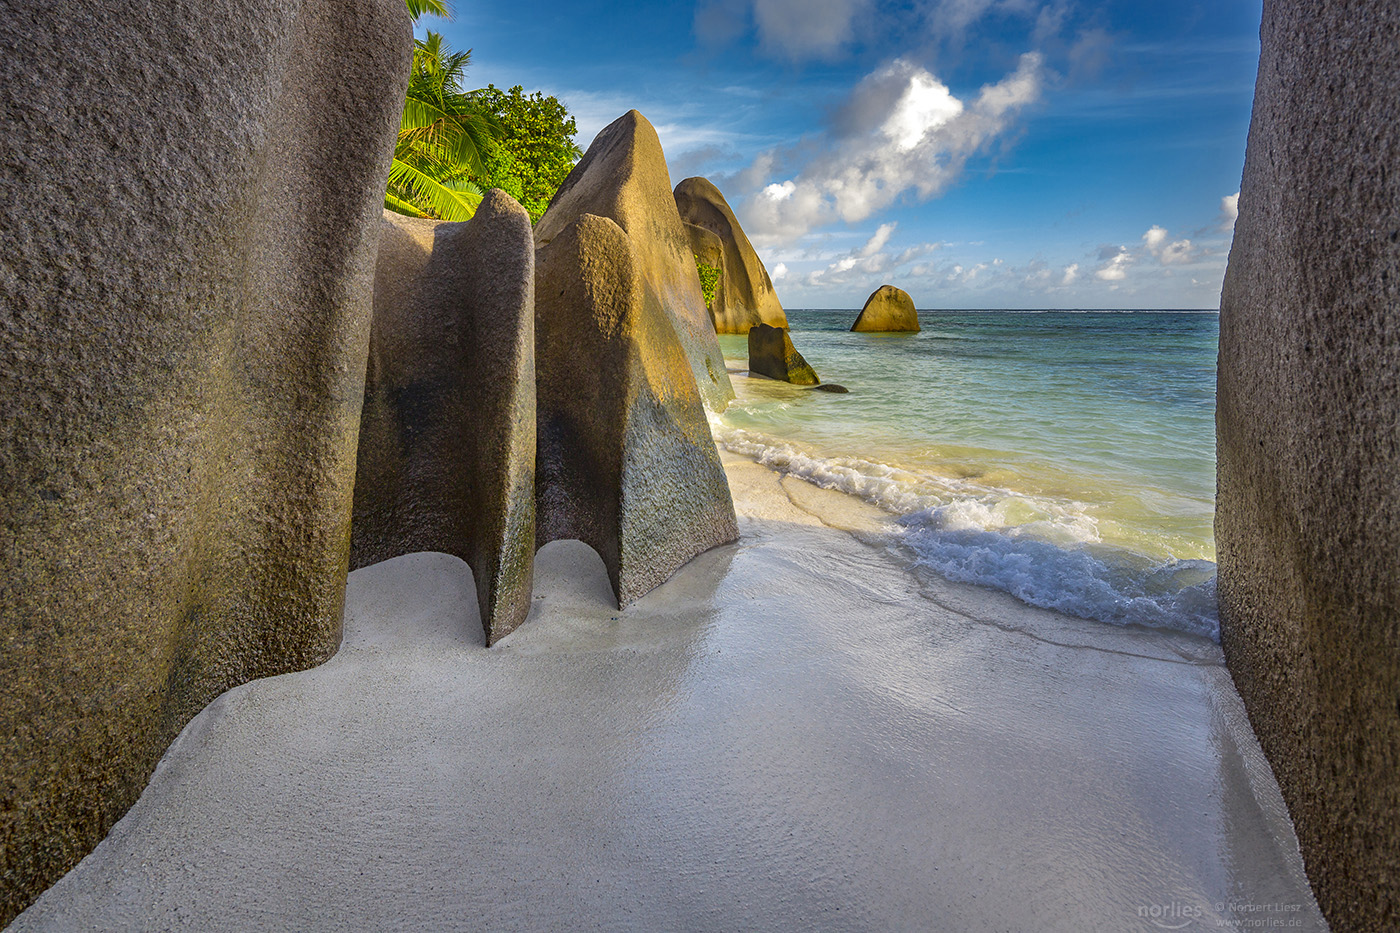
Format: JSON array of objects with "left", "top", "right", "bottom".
[{"left": 535, "top": 207, "right": 739, "bottom": 607}]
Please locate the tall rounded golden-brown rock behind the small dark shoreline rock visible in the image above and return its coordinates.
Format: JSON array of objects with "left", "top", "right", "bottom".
[{"left": 675, "top": 178, "right": 787, "bottom": 333}]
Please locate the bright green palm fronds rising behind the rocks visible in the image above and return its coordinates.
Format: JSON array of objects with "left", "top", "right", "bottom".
[{"left": 384, "top": 31, "right": 501, "bottom": 220}]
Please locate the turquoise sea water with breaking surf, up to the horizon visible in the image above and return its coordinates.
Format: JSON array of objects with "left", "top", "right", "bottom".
[{"left": 714, "top": 311, "right": 1218, "bottom": 637}]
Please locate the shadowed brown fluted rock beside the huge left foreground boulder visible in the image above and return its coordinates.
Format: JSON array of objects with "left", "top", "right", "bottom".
[{"left": 350, "top": 191, "right": 535, "bottom": 644}]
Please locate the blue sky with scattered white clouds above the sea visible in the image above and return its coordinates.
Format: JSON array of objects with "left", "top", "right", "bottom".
[{"left": 431, "top": 0, "right": 1260, "bottom": 308}]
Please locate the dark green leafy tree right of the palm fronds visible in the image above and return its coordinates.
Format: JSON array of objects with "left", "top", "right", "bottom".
[{"left": 472, "top": 84, "right": 582, "bottom": 223}]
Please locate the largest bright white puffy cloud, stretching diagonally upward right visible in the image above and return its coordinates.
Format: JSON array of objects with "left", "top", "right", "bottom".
[{"left": 741, "top": 52, "right": 1044, "bottom": 242}]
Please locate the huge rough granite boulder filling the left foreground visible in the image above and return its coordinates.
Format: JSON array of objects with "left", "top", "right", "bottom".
[{"left": 0, "top": 0, "right": 412, "bottom": 925}]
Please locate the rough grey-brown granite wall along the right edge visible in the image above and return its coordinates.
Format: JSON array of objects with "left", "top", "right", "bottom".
[{"left": 1215, "top": 0, "right": 1400, "bottom": 930}]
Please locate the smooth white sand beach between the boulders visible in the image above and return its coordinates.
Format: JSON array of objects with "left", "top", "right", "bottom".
[{"left": 11, "top": 455, "right": 1326, "bottom": 932}]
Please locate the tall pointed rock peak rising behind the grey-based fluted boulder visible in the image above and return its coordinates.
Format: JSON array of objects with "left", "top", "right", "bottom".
[{"left": 535, "top": 111, "right": 734, "bottom": 410}]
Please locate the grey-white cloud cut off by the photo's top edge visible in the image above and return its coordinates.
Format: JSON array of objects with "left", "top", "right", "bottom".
[{"left": 694, "top": 0, "right": 874, "bottom": 62}]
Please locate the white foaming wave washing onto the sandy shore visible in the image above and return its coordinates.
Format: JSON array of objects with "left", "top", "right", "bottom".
[{"left": 711, "top": 417, "right": 1219, "bottom": 640}]
